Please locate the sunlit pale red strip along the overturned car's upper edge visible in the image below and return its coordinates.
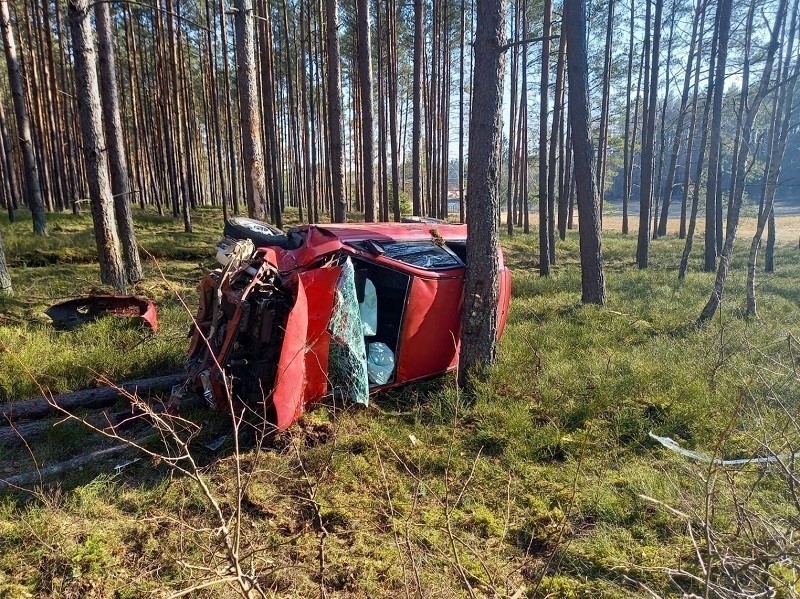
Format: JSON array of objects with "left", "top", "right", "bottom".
[{"left": 308, "top": 223, "right": 467, "bottom": 243}]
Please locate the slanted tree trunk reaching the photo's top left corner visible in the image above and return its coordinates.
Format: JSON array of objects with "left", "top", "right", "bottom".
[{"left": 0, "top": 0, "right": 47, "bottom": 235}]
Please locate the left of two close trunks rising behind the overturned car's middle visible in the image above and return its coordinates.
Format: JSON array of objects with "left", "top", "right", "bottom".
[{"left": 325, "top": 0, "right": 347, "bottom": 223}]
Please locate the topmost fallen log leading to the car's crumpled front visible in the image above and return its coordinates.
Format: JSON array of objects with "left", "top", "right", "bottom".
[{"left": 0, "top": 373, "right": 186, "bottom": 423}]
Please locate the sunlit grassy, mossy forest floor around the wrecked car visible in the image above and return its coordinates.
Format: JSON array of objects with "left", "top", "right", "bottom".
[{"left": 0, "top": 210, "right": 800, "bottom": 598}]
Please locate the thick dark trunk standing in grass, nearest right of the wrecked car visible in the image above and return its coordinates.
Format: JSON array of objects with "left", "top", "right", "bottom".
[{"left": 563, "top": 0, "right": 606, "bottom": 305}]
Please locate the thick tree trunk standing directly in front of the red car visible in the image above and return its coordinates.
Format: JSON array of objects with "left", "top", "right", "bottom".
[{"left": 459, "top": 0, "right": 505, "bottom": 385}]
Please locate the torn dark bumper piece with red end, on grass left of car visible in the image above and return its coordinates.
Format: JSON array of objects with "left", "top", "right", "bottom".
[{"left": 44, "top": 294, "right": 158, "bottom": 333}]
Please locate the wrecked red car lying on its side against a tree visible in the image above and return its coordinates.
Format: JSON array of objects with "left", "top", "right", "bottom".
[{"left": 187, "top": 218, "right": 511, "bottom": 429}]
